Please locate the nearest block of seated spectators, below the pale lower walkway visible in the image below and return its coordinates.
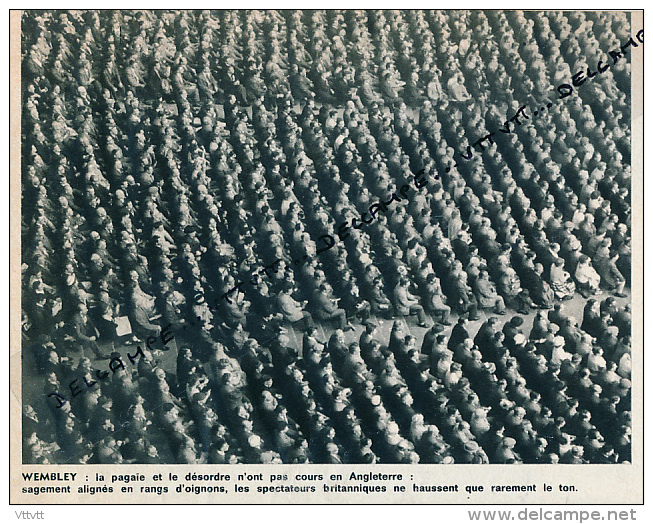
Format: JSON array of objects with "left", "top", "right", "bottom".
[{"left": 23, "top": 290, "right": 631, "bottom": 463}]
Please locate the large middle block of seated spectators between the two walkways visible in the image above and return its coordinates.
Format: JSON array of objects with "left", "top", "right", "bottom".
[{"left": 23, "top": 13, "right": 630, "bottom": 464}]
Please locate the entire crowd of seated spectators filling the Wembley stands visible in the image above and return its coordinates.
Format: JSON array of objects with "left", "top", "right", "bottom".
[{"left": 21, "top": 10, "right": 637, "bottom": 464}]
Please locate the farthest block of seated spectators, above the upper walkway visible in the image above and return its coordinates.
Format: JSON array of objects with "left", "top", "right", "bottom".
[{"left": 23, "top": 10, "right": 631, "bottom": 119}]
